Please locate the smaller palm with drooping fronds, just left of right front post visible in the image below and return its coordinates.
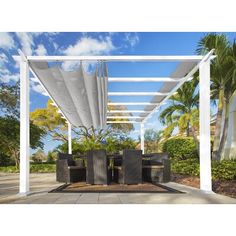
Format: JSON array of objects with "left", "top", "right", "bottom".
[{"left": 159, "top": 78, "right": 199, "bottom": 143}]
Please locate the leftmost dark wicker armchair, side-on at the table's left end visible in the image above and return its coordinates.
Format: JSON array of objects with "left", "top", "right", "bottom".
[{"left": 56, "top": 153, "right": 86, "bottom": 183}]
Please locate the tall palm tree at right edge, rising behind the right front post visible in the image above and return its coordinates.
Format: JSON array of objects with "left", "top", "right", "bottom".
[{"left": 197, "top": 33, "right": 235, "bottom": 160}]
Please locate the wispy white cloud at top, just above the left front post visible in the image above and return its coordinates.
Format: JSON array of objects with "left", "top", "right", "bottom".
[{"left": 16, "top": 32, "right": 34, "bottom": 56}]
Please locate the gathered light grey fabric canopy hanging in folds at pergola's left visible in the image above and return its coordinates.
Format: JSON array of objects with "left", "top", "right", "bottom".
[{"left": 30, "top": 61, "right": 108, "bottom": 128}]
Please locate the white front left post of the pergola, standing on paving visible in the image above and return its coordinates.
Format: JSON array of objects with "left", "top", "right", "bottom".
[{"left": 19, "top": 56, "right": 30, "bottom": 195}]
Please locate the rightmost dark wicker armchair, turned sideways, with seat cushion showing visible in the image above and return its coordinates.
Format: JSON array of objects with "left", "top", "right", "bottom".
[{"left": 142, "top": 153, "right": 171, "bottom": 183}]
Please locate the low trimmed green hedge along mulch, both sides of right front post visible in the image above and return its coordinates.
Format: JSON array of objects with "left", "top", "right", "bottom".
[{"left": 171, "top": 159, "right": 236, "bottom": 180}]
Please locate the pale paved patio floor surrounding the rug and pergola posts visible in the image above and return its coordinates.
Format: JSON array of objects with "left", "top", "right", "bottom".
[{"left": 0, "top": 173, "right": 236, "bottom": 204}]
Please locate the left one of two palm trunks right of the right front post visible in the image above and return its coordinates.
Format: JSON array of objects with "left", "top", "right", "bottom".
[{"left": 212, "top": 89, "right": 224, "bottom": 160}]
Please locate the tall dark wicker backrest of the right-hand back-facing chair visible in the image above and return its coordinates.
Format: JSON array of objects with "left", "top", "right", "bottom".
[{"left": 122, "top": 149, "right": 142, "bottom": 184}]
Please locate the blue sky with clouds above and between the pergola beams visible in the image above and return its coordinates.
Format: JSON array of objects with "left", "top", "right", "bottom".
[{"left": 0, "top": 32, "right": 236, "bottom": 152}]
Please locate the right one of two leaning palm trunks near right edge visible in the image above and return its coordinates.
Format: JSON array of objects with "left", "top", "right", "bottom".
[{"left": 216, "top": 100, "right": 230, "bottom": 160}]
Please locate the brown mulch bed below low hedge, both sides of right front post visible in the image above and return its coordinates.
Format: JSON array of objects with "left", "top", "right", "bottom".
[{"left": 172, "top": 174, "right": 236, "bottom": 198}]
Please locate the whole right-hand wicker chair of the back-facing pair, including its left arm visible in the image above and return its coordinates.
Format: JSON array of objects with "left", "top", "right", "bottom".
[{"left": 114, "top": 149, "right": 142, "bottom": 184}]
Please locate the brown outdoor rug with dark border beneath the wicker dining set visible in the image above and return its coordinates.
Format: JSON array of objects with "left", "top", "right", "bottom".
[{"left": 50, "top": 182, "right": 182, "bottom": 193}]
